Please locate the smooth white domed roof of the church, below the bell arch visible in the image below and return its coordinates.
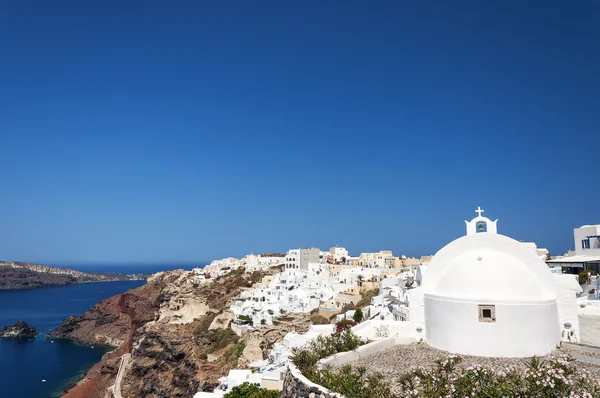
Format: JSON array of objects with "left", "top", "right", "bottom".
[{"left": 422, "top": 232, "right": 557, "bottom": 304}]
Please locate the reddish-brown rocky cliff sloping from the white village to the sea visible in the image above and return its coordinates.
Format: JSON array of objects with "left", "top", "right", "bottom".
[{"left": 51, "top": 270, "right": 309, "bottom": 398}]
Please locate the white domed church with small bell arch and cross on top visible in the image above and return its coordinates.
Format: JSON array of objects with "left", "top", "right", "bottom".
[{"left": 410, "top": 208, "right": 579, "bottom": 357}]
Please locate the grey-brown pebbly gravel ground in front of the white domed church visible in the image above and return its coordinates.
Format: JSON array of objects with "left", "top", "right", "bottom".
[{"left": 351, "top": 343, "right": 600, "bottom": 391}]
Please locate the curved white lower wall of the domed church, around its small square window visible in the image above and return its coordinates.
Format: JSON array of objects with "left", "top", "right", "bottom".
[{"left": 424, "top": 294, "right": 560, "bottom": 357}]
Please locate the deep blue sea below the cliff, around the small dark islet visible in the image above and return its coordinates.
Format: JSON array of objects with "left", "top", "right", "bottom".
[{"left": 0, "top": 264, "right": 199, "bottom": 398}]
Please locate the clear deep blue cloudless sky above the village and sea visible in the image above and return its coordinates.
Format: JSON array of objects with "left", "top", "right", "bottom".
[{"left": 0, "top": 0, "right": 600, "bottom": 263}]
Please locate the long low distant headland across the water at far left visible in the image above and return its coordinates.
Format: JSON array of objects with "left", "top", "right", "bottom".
[{"left": 0, "top": 261, "right": 148, "bottom": 290}]
